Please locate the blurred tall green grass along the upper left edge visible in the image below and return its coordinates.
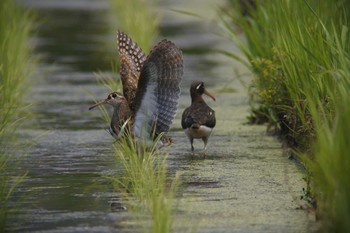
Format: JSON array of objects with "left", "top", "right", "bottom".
[{"left": 0, "top": 0, "right": 33, "bottom": 140}]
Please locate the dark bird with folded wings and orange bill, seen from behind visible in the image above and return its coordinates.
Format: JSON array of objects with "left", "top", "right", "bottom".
[{"left": 181, "top": 81, "right": 216, "bottom": 151}]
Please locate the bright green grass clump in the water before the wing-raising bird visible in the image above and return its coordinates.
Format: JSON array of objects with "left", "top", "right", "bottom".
[{"left": 114, "top": 135, "right": 179, "bottom": 233}]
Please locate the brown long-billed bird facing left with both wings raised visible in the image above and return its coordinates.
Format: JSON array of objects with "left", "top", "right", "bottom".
[{"left": 89, "top": 31, "right": 183, "bottom": 146}]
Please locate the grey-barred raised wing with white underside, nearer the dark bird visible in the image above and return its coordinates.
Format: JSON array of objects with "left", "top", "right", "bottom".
[{"left": 134, "top": 40, "right": 183, "bottom": 142}]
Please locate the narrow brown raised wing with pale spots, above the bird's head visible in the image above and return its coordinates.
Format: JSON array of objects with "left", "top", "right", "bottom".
[{"left": 117, "top": 31, "right": 146, "bottom": 103}]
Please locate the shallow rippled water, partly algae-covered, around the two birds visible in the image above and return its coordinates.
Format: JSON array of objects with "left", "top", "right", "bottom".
[{"left": 9, "top": 0, "right": 312, "bottom": 232}]
